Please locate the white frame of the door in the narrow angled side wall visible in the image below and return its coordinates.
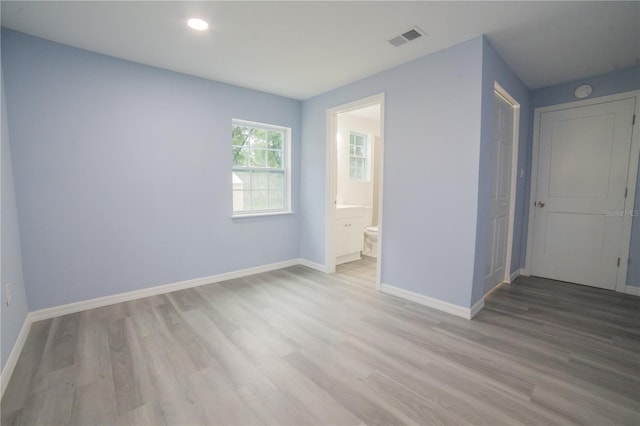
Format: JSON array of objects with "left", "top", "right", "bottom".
[{"left": 491, "top": 82, "right": 520, "bottom": 284}]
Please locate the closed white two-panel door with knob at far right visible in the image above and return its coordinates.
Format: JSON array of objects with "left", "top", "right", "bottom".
[{"left": 531, "top": 98, "right": 635, "bottom": 289}]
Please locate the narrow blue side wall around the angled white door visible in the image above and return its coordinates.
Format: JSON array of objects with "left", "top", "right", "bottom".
[{"left": 472, "top": 38, "right": 531, "bottom": 303}]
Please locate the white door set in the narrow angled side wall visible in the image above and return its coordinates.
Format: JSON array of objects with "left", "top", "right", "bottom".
[{"left": 484, "top": 93, "right": 514, "bottom": 291}]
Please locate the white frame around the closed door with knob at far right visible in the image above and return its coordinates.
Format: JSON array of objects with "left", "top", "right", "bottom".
[{"left": 522, "top": 90, "right": 640, "bottom": 294}]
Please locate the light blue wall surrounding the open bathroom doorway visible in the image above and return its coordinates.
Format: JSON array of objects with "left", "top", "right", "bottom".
[{"left": 300, "top": 37, "right": 483, "bottom": 307}]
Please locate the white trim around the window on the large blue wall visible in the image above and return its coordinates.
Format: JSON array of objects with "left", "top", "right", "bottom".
[{"left": 230, "top": 118, "right": 294, "bottom": 219}]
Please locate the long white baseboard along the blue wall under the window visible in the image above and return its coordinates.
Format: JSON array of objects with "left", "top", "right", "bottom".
[{"left": 30, "top": 259, "right": 300, "bottom": 321}]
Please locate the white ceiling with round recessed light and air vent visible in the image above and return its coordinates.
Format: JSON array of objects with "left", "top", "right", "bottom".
[{"left": 1, "top": 0, "right": 640, "bottom": 99}]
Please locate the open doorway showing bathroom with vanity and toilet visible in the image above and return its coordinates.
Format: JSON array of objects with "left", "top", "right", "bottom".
[{"left": 325, "top": 94, "right": 384, "bottom": 289}]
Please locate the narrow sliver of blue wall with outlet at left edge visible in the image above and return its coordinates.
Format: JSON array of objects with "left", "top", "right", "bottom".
[{"left": 0, "top": 62, "right": 28, "bottom": 369}]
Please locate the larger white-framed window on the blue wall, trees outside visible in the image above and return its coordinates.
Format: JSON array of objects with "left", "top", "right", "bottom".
[{"left": 231, "top": 120, "right": 291, "bottom": 216}]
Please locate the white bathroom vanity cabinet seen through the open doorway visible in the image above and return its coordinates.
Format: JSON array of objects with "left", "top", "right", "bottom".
[{"left": 335, "top": 206, "right": 365, "bottom": 265}]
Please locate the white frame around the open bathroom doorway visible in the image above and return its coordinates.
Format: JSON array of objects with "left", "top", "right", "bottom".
[{"left": 324, "top": 92, "right": 385, "bottom": 290}]
